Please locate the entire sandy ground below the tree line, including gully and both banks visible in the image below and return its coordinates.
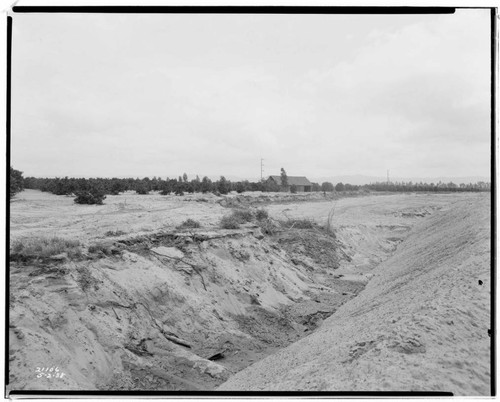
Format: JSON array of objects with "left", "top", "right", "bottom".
[{"left": 8, "top": 190, "right": 491, "bottom": 395}]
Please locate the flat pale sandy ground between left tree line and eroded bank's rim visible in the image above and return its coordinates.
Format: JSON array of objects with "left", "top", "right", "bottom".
[{"left": 10, "top": 190, "right": 227, "bottom": 242}]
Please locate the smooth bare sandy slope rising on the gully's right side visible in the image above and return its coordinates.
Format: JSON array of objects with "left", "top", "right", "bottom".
[{"left": 220, "top": 195, "right": 491, "bottom": 395}]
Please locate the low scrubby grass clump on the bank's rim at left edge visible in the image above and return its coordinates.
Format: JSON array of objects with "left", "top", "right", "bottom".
[{"left": 10, "top": 236, "right": 82, "bottom": 261}]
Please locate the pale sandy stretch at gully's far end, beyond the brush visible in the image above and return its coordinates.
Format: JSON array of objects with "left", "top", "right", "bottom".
[{"left": 267, "top": 193, "right": 468, "bottom": 277}]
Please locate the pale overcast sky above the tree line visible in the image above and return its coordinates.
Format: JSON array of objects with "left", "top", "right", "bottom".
[{"left": 11, "top": 10, "right": 491, "bottom": 179}]
